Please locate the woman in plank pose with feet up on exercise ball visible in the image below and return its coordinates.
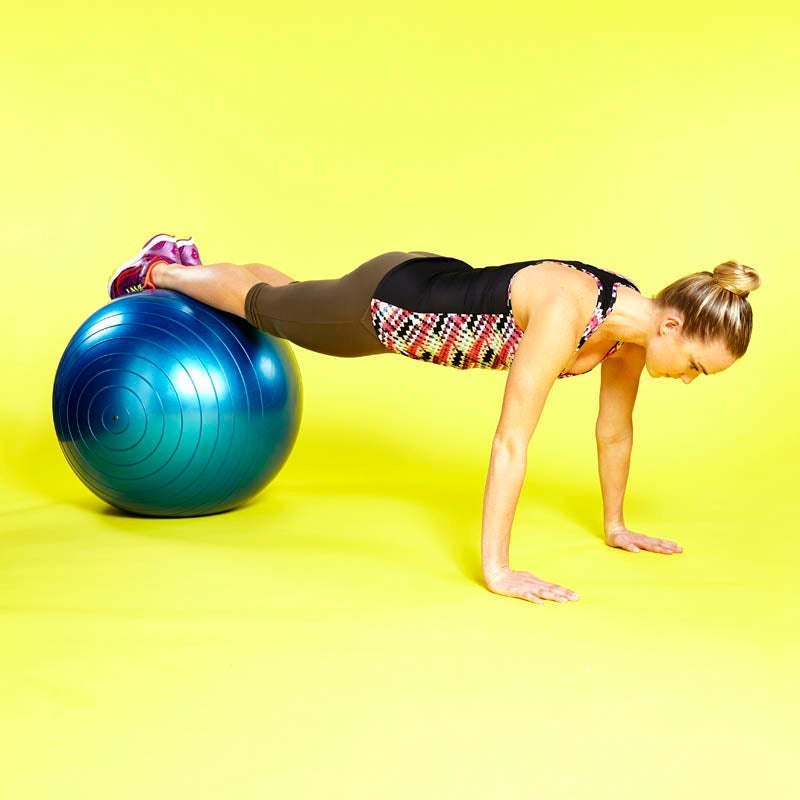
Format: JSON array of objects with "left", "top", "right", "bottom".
[{"left": 108, "top": 234, "right": 761, "bottom": 603}]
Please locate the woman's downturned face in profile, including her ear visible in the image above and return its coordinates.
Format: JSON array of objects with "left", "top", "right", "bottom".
[{"left": 645, "top": 311, "right": 736, "bottom": 383}]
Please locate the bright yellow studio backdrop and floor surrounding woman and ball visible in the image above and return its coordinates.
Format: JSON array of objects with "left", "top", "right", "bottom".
[{"left": 0, "top": 0, "right": 800, "bottom": 800}]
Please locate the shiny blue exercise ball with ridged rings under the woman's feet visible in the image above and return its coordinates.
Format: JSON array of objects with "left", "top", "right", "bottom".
[{"left": 53, "top": 290, "right": 303, "bottom": 517}]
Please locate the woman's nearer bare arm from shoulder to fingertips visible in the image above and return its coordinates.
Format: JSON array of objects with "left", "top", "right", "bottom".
[{"left": 481, "top": 293, "right": 582, "bottom": 603}]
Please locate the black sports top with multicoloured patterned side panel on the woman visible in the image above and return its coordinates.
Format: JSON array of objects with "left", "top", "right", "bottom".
[{"left": 370, "top": 256, "right": 639, "bottom": 378}]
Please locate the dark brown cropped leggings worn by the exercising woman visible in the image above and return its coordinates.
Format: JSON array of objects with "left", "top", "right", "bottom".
[{"left": 244, "top": 250, "right": 439, "bottom": 358}]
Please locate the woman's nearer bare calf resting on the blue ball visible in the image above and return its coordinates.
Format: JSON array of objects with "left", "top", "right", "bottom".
[{"left": 150, "top": 262, "right": 258, "bottom": 319}]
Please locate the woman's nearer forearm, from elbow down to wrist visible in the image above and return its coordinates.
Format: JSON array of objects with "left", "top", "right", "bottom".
[{"left": 481, "top": 442, "right": 528, "bottom": 580}]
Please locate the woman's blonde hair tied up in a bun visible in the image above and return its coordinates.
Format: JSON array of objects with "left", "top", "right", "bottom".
[{"left": 653, "top": 261, "right": 761, "bottom": 358}]
